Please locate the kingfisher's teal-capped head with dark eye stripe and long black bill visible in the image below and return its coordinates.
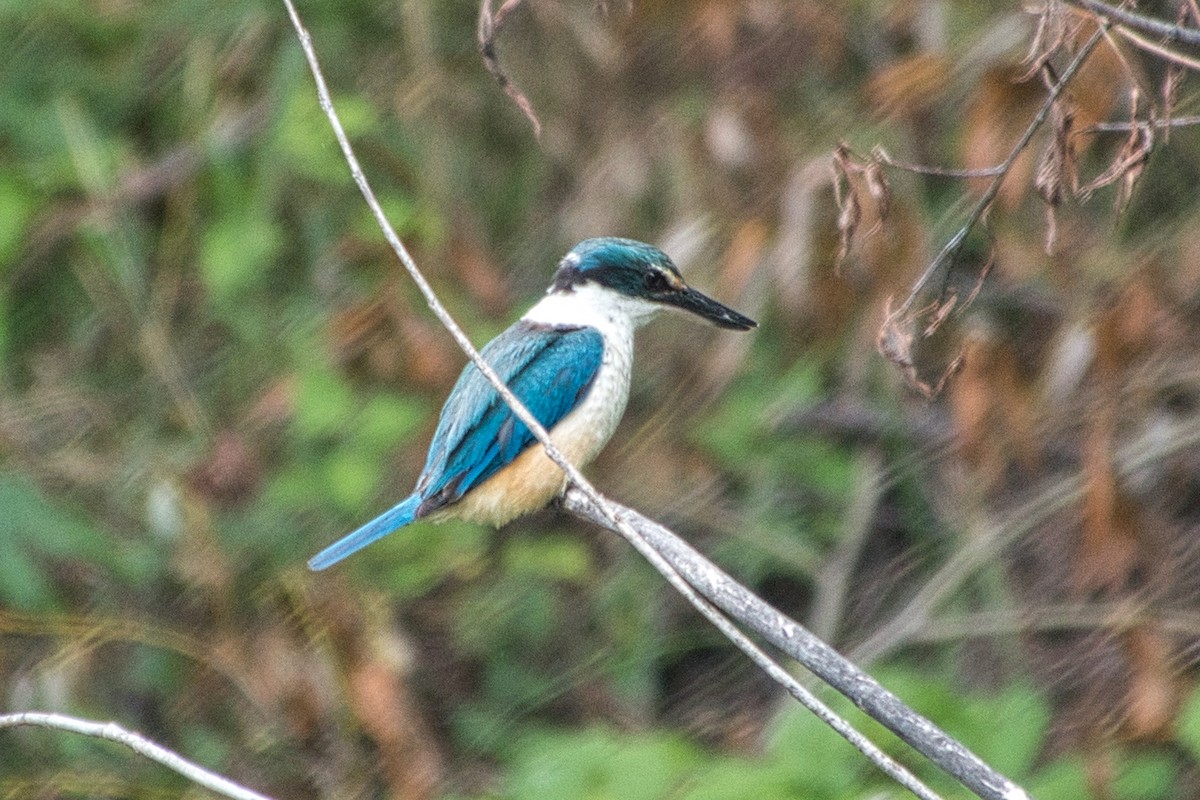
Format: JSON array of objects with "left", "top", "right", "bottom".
[{"left": 550, "top": 237, "right": 757, "bottom": 331}]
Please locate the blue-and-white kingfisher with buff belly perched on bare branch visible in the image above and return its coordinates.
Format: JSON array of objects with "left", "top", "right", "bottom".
[{"left": 308, "top": 236, "right": 757, "bottom": 571}]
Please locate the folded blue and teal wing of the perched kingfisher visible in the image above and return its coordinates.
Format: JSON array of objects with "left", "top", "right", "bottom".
[{"left": 416, "top": 321, "right": 604, "bottom": 517}]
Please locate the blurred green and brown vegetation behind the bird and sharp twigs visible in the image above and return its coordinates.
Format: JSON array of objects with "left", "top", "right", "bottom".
[{"left": 7, "top": 0, "right": 1200, "bottom": 800}]
